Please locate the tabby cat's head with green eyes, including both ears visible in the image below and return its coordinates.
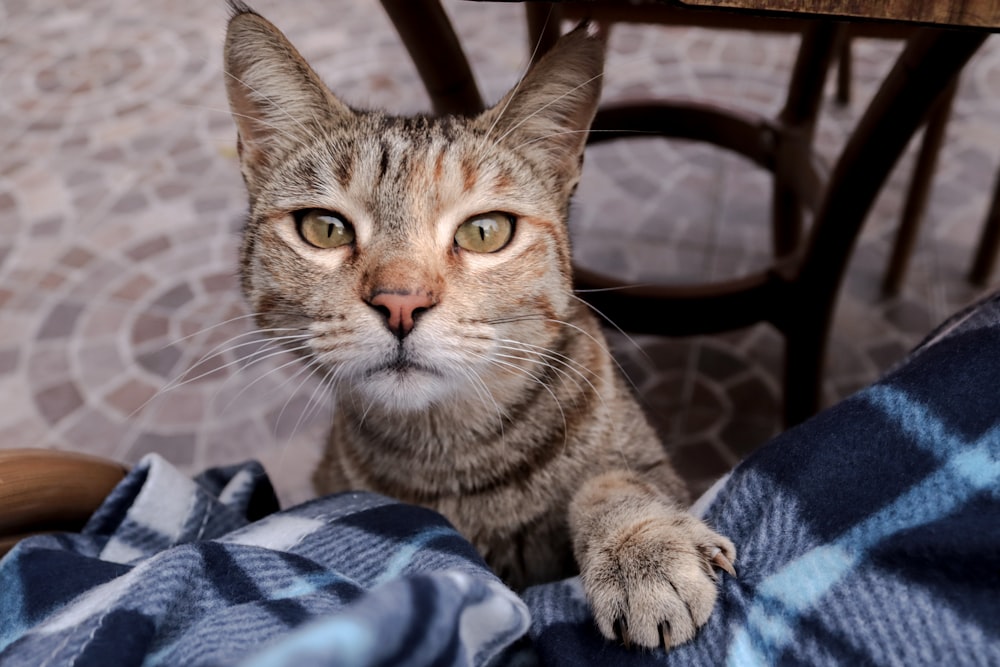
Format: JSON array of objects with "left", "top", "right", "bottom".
[{"left": 225, "top": 5, "right": 604, "bottom": 410}]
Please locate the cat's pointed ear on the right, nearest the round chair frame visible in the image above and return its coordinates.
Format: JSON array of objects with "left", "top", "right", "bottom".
[{"left": 483, "top": 23, "right": 607, "bottom": 185}]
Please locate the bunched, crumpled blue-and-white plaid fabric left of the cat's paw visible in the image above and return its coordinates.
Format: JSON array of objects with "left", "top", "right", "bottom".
[{"left": 0, "top": 455, "right": 529, "bottom": 667}]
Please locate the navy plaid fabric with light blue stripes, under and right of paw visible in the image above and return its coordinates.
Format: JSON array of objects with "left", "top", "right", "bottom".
[{"left": 524, "top": 296, "right": 1000, "bottom": 667}]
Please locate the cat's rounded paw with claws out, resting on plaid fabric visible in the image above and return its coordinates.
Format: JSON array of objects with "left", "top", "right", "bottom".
[{"left": 581, "top": 513, "right": 736, "bottom": 650}]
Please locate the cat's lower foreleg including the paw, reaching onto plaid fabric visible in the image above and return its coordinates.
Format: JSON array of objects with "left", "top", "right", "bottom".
[{"left": 569, "top": 471, "right": 736, "bottom": 649}]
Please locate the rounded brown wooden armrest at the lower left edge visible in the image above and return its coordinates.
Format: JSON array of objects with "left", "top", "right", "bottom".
[{"left": 0, "top": 449, "right": 128, "bottom": 555}]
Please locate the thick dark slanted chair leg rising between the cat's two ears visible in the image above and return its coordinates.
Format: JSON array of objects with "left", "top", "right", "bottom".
[{"left": 382, "top": 0, "right": 484, "bottom": 114}]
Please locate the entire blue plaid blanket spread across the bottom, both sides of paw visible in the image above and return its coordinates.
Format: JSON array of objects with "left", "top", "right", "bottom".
[{"left": 0, "top": 298, "right": 1000, "bottom": 667}]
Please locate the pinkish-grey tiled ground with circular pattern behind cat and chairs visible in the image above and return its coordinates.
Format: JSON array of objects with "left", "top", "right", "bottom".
[{"left": 0, "top": 0, "right": 1000, "bottom": 501}]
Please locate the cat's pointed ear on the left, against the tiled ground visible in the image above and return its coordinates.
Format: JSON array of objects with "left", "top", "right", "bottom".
[{"left": 224, "top": 1, "right": 353, "bottom": 183}]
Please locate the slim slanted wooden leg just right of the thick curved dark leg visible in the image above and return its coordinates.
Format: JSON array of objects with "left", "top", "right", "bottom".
[{"left": 882, "top": 78, "right": 958, "bottom": 296}]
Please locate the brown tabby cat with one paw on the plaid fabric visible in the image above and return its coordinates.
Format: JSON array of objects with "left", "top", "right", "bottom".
[{"left": 224, "top": 0, "right": 736, "bottom": 649}]
